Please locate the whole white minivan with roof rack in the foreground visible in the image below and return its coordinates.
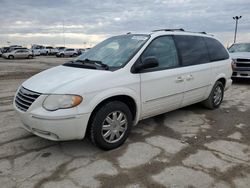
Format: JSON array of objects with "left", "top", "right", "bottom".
[{"left": 14, "top": 29, "right": 232, "bottom": 150}]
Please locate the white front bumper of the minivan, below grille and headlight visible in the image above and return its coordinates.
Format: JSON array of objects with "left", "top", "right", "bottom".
[{"left": 14, "top": 93, "right": 90, "bottom": 141}]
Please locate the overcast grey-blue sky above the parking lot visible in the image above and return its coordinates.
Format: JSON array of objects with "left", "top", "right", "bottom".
[{"left": 0, "top": 0, "right": 250, "bottom": 47}]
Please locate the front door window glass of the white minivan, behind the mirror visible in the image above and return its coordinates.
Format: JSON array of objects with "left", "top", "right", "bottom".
[{"left": 141, "top": 36, "right": 178, "bottom": 69}]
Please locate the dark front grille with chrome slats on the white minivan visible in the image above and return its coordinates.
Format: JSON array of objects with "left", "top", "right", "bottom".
[{"left": 15, "top": 87, "right": 41, "bottom": 112}]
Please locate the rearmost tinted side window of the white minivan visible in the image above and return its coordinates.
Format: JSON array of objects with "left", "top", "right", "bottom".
[{"left": 204, "top": 37, "right": 229, "bottom": 61}]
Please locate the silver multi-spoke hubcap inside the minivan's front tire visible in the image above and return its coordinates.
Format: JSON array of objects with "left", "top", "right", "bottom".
[{"left": 102, "top": 111, "right": 128, "bottom": 143}]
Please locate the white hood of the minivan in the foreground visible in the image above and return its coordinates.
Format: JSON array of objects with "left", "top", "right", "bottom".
[{"left": 22, "top": 65, "right": 107, "bottom": 93}]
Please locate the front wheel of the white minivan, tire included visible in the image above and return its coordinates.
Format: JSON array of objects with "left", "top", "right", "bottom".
[{"left": 88, "top": 101, "right": 132, "bottom": 150}]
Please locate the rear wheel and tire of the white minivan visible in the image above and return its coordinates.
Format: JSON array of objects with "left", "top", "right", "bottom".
[{"left": 203, "top": 81, "right": 224, "bottom": 110}]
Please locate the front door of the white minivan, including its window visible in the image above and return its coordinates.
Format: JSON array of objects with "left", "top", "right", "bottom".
[{"left": 140, "top": 36, "right": 185, "bottom": 118}]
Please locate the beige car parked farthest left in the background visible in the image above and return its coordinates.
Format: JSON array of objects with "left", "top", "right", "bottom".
[{"left": 2, "top": 49, "right": 34, "bottom": 59}]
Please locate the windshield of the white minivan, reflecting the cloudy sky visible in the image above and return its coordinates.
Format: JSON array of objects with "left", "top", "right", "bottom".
[{"left": 75, "top": 34, "right": 149, "bottom": 68}]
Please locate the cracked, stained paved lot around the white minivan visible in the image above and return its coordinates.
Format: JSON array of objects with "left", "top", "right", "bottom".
[{"left": 0, "top": 57, "right": 250, "bottom": 188}]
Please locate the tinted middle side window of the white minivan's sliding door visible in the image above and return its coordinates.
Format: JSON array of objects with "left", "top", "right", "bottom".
[{"left": 174, "top": 35, "right": 209, "bottom": 66}]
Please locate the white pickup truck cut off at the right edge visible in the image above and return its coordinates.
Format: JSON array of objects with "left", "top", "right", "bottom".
[{"left": 229, "top": 43, "right": 250, "bottom": 78}]
